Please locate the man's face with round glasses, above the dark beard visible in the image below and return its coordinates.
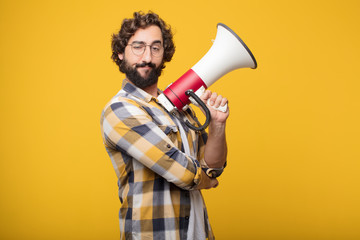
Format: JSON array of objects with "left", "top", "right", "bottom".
[{"left": 118, "top": 25, "right": 163, "bottom": 81}]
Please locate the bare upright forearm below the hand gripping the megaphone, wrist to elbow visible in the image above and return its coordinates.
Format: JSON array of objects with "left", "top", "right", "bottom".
[{"left": 204, "top": 122, "right": 227, "bottom": 168}]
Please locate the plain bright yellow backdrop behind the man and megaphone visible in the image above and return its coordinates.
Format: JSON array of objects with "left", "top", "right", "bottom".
[{"left": 0, "top": 0, "right": 360, "bottom": 240}]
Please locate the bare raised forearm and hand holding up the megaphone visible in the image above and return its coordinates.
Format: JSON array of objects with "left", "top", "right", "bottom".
[{"left": 201, "top": 90, "right": 229, "bottom": 168}]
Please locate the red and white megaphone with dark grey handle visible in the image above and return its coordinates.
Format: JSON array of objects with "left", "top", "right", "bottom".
[{"left": 157, "top": 23, "right": 257, "bottom": 131}]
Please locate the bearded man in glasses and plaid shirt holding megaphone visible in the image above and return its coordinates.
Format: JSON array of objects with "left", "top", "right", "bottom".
[{"left": 101, "top": 12, "right": 229, "bottom": 240}]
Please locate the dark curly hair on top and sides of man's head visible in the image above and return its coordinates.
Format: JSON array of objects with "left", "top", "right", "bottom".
[{"left": 111, "top": 11, "right": 175, "bottom": 71}]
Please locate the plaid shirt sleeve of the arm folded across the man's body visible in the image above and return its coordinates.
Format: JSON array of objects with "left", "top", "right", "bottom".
[{"left": 101, "top": 98, "right": 202, "bottom": 190}]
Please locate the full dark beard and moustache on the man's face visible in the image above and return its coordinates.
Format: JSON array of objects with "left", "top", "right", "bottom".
[{"left": 120, "top": 59, "right": 163, "bottom": 89}]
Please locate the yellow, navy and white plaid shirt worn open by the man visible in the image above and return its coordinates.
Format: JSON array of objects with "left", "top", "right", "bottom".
[{"left": 101, "top": 80, "right": 214, "bottom": 240}]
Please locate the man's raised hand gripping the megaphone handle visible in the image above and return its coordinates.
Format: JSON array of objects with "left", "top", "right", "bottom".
[{"left": 200, "top": 90, "right": 229, "bottom": 123}]
